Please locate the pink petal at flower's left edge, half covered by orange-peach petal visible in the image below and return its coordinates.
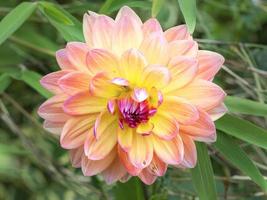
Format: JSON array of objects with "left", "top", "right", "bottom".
[{"left": 40, "top": 70, "right": 72, "bottom": 94}]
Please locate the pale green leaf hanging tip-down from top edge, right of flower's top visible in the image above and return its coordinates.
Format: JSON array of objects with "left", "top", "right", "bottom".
[{"left": 178, "top": 0, "right": 197, "bottom": 34}]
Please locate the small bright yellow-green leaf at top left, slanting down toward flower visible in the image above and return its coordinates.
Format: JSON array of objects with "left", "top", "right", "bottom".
[{"left": 40, "top": 1, "right": 74, "bottom": 25}]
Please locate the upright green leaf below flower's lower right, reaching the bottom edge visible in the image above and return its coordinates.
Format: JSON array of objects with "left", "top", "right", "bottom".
[{"left": 191, "top": 142, "right": 217, "bottom": 200}]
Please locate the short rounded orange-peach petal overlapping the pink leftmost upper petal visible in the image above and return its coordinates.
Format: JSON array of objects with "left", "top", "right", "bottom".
[{"left": 57, "top": 71, "right": 91, "bottom": 95}]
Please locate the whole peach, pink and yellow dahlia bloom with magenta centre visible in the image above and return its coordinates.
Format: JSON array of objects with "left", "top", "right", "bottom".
[{"left": 38, "top": 7, "right": 226, "bottom": 184}]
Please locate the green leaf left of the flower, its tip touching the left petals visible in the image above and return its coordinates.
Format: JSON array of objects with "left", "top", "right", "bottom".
[{"left": 20, "top": 70, "right": 51, "bottom": 98}]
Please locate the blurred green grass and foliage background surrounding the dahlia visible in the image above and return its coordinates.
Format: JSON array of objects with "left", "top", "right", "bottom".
[{"left": 0, "top": 0, "right": 267, "bottom": 200}]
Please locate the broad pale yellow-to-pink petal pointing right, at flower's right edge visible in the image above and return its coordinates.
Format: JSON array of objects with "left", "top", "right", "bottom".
[{"left": 175, "top": 79, "right": 225, "bottom": 110}]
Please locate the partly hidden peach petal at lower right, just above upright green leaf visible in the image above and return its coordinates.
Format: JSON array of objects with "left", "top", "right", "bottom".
[{"left": 180, "top": 134, "right": 197, "bottom": 168}]
